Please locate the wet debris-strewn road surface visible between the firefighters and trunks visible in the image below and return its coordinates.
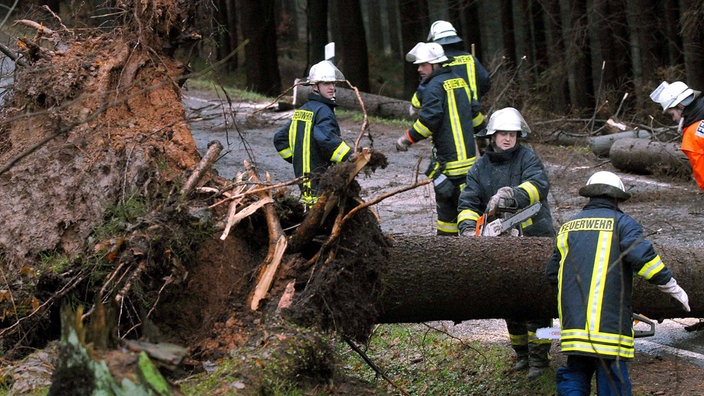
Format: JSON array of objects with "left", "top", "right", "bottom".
[{"left": 184, "top": 83, "right": 704, "bottom": 395}]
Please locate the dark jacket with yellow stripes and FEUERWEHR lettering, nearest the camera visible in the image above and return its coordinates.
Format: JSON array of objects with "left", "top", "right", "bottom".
[{"left": 546, "top": 197, "right": 672, "bottom": 359}]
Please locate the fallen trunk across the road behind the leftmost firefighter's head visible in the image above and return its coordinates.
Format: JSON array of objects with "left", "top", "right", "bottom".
[{"left": 296, "top": 84, "right": 412, "bottom": 120}]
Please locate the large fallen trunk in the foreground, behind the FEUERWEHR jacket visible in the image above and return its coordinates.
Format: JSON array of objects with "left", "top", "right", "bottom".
[{"left": 378, "top": 235, "right": 704, "bottom": 323}]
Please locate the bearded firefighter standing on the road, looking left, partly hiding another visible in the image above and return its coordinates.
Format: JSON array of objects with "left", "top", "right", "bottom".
[{"left": 396, "top": 43, "right": 484, "bottom": 236}]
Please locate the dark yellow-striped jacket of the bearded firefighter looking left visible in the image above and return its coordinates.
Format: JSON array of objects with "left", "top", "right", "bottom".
[{"left": 407, "top": 67, "right": 484, "bottom": 178}]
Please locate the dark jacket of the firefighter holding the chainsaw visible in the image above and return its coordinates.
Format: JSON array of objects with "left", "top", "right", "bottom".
[{"left": 457, "top": 144, "right": 555, "bottom": 236}]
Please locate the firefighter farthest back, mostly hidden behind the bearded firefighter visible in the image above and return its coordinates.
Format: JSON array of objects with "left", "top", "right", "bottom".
[{"left": 417, "top": 21, "right": 491, "bottom": 103}]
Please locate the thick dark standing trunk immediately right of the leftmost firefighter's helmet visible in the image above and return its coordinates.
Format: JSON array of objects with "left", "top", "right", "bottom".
[{"left": 335, "top": 0, "right": 369, "bottom": 92}]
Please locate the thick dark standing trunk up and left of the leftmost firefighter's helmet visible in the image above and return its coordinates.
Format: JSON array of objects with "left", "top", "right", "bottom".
[{"left": 239, "top": 1, "right": 281, "bottom": 96}]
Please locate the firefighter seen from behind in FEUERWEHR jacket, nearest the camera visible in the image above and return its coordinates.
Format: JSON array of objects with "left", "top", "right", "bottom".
[{"left": 546, "top": 171, "right": 690, "bottom": 395}]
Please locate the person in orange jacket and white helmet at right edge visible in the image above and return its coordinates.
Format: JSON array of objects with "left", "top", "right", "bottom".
[{"left": 650, "top": 81, "right": 704, "bottom": 190}]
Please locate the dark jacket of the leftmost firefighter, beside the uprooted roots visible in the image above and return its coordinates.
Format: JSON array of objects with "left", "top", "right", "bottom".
[{"left": 274, "top": 92, "right": 352, "bottom": 206}]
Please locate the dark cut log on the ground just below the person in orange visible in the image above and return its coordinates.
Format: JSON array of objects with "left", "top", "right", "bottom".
[{"left": 609, "top": 138, "right": 692, "bottom": 177}]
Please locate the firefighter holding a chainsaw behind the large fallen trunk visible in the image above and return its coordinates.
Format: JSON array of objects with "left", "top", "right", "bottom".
[{"left": 458, "top": 107, "right": 555, "bottom": 379}]
